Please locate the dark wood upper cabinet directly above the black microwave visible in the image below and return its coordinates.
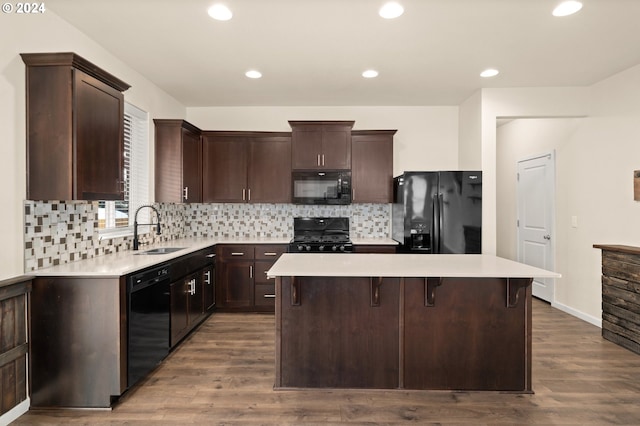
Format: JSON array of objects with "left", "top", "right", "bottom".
[{"left": 289, "top": 121, "right": 354, "bottom": 170}]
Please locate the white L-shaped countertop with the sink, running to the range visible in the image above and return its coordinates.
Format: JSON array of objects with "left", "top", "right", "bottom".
[{"left": 29, "top": 237, "right": 290, "bottom": 278}]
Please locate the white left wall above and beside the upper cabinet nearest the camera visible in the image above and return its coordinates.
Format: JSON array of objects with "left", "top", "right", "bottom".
[{"left": 0, "top": 10, "right": 185, "bottom": 279}]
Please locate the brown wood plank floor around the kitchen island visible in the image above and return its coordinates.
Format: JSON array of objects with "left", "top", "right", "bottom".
[{"left": 15, "top": 300, "right": 640, "bottom": 425}]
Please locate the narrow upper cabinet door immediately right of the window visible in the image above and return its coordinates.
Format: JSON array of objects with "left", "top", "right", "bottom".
[{"left": 182, "top": 129, "right": 202, "bottom": 203}]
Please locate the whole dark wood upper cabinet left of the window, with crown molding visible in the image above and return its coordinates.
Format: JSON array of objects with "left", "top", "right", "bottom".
[{"left": 20, "top": 52, "right": 130, "bottom": 200}]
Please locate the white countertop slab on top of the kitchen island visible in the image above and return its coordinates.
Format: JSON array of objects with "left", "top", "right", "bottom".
[{"left": 267, "top": 253, "right": 560, "bottom": 278}]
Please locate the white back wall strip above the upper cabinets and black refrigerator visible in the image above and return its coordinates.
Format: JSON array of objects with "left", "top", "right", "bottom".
[{"left": 187, "top": 106, "right": 458, "bottom": 175}]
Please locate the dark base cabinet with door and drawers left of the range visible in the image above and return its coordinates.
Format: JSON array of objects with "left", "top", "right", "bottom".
[{"left": 216, "top": 244, "right": 287, "bottom": 312}]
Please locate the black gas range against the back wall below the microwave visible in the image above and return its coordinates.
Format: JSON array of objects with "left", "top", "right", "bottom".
[{"left": 289, "top": 217, "right": 353, "bottom": 253}]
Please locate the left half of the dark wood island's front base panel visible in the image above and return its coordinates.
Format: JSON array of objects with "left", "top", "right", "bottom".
[{"left": 276, "top": 277, "right": 400, "bottom": 389}]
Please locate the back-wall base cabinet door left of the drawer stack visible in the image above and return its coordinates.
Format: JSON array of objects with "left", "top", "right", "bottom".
[{"left": 219, "top": 260, "right": 254, "bottom": 308}]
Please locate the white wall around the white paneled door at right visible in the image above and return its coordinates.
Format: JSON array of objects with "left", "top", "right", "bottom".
[{"left": 490, "top": 66, "right": 640, "bottom": 324}]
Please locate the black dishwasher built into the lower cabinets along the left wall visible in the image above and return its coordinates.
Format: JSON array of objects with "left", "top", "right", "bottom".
[{"left": 127, "top": 265, "right": 171, "bottom": 388}]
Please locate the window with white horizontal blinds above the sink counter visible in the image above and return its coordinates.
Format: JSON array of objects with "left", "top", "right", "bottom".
[{"left": 98, "top": 102, "right": 149, "bottom": 236}]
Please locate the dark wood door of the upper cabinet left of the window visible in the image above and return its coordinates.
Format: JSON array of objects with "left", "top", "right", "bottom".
[{"left": 74, "top": 69, "right": 124, "bottom": 200}]
